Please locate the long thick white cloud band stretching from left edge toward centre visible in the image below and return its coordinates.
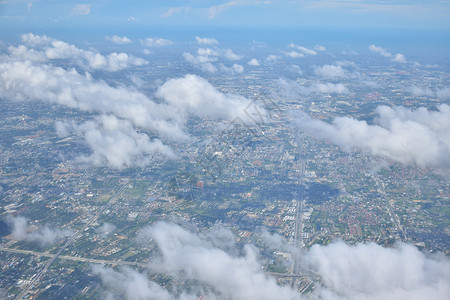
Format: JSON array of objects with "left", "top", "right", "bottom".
[{"left": 0, "top": 62, "right": 187, "bottom": 139}]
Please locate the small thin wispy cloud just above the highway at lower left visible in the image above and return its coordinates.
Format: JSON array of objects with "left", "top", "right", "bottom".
[{"left": 6, "top": 216, "right": 73, "bottom": 246}]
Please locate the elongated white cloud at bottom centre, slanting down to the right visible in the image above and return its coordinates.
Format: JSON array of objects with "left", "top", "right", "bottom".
[{"left": 135, "top": 222, "right": 300, "bottom": 299}]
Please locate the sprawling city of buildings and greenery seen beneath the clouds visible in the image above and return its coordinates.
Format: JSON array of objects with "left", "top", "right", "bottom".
[{"left": 0, "top": 31, "right": 450, "bottom": 299}]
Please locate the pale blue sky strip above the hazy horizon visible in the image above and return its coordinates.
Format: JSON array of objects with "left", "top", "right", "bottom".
[{"left": 0, "top": 0, "right": 450, "bottom": 29}]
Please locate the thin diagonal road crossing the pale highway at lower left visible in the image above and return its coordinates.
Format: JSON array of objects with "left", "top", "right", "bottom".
[{"left": 16, "top": 185, "right": 126, "bottom": 299}]
